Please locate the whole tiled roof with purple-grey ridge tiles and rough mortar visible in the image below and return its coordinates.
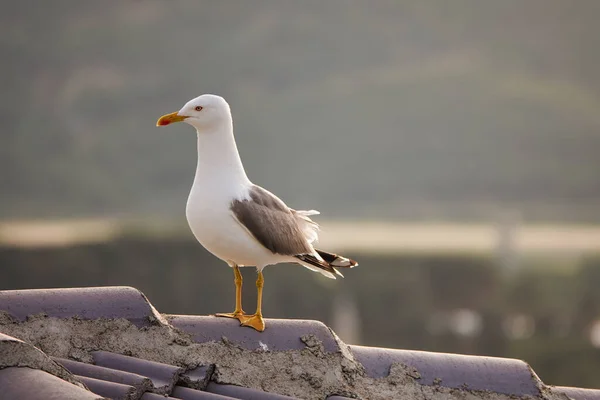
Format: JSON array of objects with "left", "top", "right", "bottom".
[{"left": 0, "top": 287, "right": 600, "bottom": 400}]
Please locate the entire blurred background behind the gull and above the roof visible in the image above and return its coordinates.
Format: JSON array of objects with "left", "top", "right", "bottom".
[{"left": 0, "top": 0, "right": 600, "bottom": 387}]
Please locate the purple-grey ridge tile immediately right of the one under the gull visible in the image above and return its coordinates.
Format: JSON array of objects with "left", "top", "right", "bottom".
[{"left": 350, "top": 346, "right": 541, "bottom": 396}]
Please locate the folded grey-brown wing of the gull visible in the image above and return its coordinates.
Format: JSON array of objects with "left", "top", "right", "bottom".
[{"left": 231, "top": 185, "right": 314, "bottom": 256}]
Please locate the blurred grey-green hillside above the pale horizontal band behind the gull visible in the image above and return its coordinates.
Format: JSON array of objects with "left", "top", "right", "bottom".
[{"left": 0, "top": 0, "right": 600, "bottom": 222}]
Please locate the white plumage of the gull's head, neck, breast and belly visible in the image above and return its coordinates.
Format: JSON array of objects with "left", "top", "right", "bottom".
[{"left": 178, "top": 95, "right": 334, "bottom": 278}]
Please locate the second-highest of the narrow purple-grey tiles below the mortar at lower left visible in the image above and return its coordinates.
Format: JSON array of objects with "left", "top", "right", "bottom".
[{"left": 52, "top": 357, "right": 152, "bottom": 399}]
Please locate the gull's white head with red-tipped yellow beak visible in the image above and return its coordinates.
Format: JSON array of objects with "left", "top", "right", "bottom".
[{"left": 156, "top": 94, "right": 231, "bottom": 132}]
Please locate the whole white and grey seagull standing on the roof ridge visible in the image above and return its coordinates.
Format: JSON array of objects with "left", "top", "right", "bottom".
[{"left": 156, "top": 94, "right": 358, "bottom": 332}]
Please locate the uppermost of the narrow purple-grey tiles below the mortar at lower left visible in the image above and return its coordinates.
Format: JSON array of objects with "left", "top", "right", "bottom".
[{"left": 92, "top": 351, "right": 183, "bottom": 394}]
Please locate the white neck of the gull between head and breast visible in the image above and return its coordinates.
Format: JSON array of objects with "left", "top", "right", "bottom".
[{"left": 192, "top": 120, "right": 250, "bottom": 193}]
